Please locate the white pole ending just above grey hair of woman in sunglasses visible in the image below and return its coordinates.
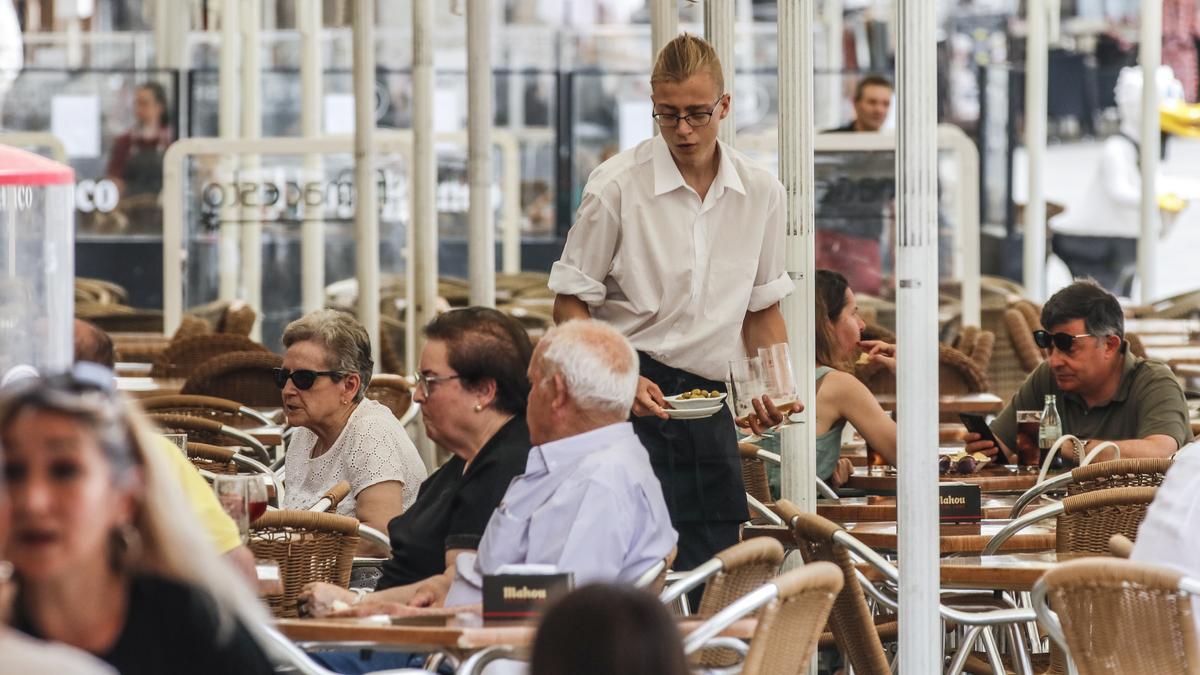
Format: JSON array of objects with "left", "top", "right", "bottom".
[{"left": 296, "top": 0, "right": 325, "bottom": 313}]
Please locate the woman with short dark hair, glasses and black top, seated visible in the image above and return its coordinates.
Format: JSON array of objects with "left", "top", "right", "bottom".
[{"left": 292, "top": 307, "right": 533, "bottom": 619}]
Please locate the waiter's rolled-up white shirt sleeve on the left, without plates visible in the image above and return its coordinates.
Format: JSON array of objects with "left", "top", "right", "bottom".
[{"left": 550, "top": 187, "right": 620, "bottom": 306}]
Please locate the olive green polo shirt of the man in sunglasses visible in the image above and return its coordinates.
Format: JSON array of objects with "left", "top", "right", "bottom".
[{"left": 991, "top": 342, "right": 1192, "bottom": 452}]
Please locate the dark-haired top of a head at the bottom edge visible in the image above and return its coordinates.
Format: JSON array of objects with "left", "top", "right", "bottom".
[{"left": 529, "top": 584, "right": 690, "bottom": 675}]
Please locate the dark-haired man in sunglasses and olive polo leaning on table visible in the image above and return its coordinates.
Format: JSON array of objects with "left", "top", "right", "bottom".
[{"left": 967, "top": 280, "right": 1192, "bottom": 461}]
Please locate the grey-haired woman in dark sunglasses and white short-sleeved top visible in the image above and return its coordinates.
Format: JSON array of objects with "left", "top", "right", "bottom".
[{"left": 275, "top": 309, "right": 426, "bottom": 546}]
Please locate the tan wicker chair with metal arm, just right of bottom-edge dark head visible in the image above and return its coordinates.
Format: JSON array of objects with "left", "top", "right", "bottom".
[{"left": 684, "top": 562, "right": 844, "bottom": 675}]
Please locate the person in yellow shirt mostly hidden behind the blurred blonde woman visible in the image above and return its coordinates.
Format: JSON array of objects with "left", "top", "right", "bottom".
[{"left": 74, "top": 318, "right": 257, "bottom": 584}]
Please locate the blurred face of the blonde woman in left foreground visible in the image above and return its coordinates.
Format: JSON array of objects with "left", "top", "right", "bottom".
[{"left": 0, "top": 410, "right": 134, "bottom": 581}]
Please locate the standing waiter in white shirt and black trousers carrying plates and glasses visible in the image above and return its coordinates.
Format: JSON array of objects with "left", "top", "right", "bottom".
[{"left": 550, "top": 34, "right": 793, "bottom": 569}]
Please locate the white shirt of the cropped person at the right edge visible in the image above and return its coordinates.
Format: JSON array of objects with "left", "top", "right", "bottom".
[{"left": 1129, "top": 441, "right": 1200, "bottom": 631}]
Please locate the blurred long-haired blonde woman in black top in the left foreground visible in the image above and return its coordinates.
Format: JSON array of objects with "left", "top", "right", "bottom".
[{"left": 0, "top": 364, "right": 272, "bottom": 675}]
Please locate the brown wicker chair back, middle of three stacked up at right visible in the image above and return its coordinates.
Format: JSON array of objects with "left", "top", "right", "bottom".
[{"left": 1055, "top": 488, "right": 1158, "bottom": 555}]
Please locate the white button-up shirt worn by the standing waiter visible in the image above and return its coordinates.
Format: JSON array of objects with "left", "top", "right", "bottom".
[{"left": 550, "top": 136, "right": 793, "bottom": 381}]
